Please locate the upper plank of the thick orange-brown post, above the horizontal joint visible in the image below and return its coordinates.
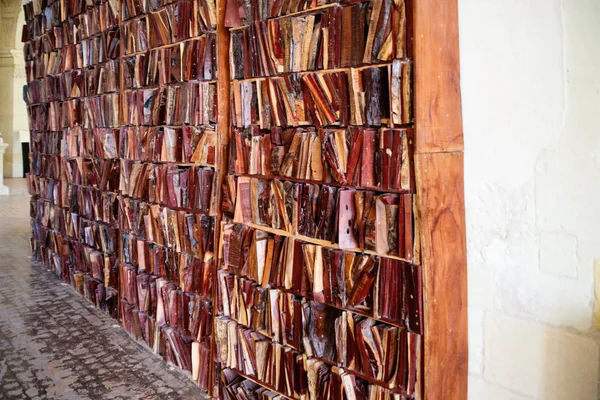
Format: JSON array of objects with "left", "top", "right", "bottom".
[{"left": 412, "top": 0, "right": 464, "bottom": 153}]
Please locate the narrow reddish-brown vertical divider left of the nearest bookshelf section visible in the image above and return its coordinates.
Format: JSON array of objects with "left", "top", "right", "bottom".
[{"left": 209, "top": 0, "right": 231, "bottom": 399}]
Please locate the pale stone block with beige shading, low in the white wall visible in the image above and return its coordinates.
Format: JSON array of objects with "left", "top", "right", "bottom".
[{"left": 484, "top": 313, "right": 599, "bottom": 400}]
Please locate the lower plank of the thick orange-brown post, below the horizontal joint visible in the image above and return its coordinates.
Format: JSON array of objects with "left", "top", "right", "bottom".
[{"left": 415, "top": 152, "right": 468, "bottom": 400}]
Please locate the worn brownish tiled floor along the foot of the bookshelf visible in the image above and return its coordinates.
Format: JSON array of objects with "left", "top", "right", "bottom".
[{"left": 0, "top": 179, "right": 202, "bottom": 400}]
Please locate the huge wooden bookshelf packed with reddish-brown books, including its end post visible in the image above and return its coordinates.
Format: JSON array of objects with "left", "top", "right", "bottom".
[{"left": 24, "top": 0, "right": 468, "bottom": 400}]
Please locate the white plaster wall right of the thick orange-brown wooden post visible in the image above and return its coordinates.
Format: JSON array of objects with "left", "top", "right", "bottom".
[{"left": 459, "top": 0, "right": 600, "bottom": 400}]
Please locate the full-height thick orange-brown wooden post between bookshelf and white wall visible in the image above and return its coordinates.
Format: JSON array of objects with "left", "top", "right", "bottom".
[{"left": 413, "top": 0, "right": 468, "bottom": 400}]
